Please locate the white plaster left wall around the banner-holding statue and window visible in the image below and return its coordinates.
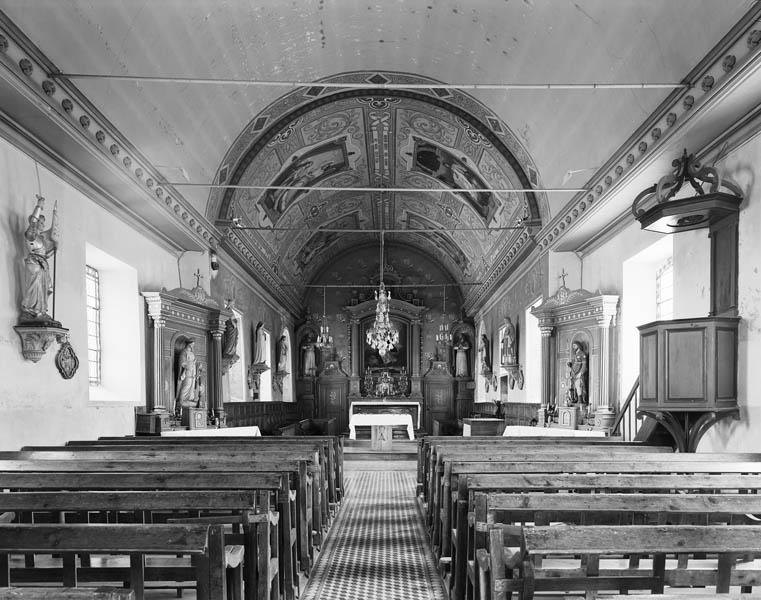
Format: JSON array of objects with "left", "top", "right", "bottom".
[{"left": 0, "top": 134, "right": 180, "bottom": 450}]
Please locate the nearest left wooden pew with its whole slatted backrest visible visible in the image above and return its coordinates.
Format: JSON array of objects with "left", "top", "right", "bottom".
[{"left": 0, "top": 524, "right": 227, "bottom": 600}]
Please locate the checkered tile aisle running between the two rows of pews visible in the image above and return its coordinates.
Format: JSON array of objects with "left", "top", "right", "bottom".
[{"left": 301, "top": 471, "right": 445, "bottom": 600}]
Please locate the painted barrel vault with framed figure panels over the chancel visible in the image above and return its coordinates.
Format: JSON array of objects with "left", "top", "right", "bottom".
[{"left": 214, "top": 72, "right": 546, "bottom": 300}]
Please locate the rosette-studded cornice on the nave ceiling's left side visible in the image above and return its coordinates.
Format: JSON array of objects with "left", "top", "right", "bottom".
[{"left": 0, "top": 12, "right": 219, "bottom": 247}]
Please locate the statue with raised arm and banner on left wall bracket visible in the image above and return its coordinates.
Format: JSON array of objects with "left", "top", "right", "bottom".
[{"left": 21, "top": 196, "right": 59, "bottom": 322}]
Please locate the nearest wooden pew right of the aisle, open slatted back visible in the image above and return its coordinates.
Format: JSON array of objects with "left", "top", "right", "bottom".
[{"left": 478, "top": 525, "right": 761, "bottom": 600}]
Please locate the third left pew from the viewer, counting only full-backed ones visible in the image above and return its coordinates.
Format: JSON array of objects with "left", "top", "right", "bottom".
[{"left": 0, "top": 471, "right": 296, "bottom": 596}]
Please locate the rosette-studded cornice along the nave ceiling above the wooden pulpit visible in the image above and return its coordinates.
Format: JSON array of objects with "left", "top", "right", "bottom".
[{"left": 537, "top": 4, "right": 761, "bottom": 251}]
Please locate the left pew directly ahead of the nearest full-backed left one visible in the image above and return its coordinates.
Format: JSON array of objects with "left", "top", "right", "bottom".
[{"left": 0, "top": 492, "right": 280, "bottom": 600}]
